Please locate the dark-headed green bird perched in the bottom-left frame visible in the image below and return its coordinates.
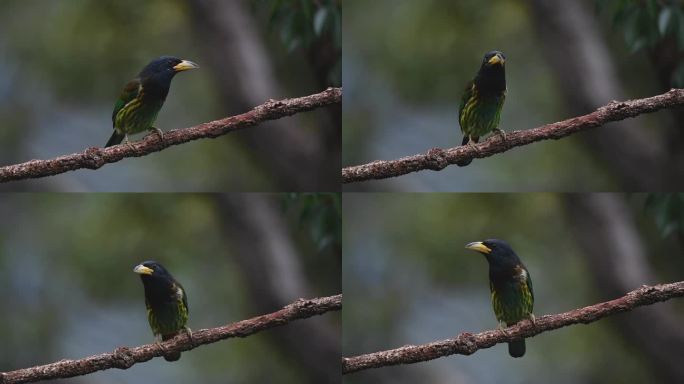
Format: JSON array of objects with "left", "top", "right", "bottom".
[{"left": 133, "top": 261, "right": 192, "bottom": 361}]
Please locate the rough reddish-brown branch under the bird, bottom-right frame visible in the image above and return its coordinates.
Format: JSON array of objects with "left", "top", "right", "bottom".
[{"left": 342, "top": 281, "right": 684, "bottom": 374}]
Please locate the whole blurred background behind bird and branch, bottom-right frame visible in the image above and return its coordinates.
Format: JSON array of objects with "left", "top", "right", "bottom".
[{"left": 342, "top": 193, "right": 684, "bottom": 384}]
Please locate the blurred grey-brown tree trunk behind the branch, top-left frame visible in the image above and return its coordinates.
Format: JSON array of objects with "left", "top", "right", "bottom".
[{"left": 186, "top": 0, "right": 341, "bottom": 190}]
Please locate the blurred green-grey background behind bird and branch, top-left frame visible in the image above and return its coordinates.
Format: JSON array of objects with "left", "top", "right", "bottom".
[{"left": 0, "top": 0, "right": 341, "bottom": 192}]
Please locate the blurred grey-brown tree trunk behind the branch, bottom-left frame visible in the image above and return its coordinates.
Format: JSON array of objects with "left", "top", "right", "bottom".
[{"left": 217, "top": 195, "right": 342, "bottom": 383}]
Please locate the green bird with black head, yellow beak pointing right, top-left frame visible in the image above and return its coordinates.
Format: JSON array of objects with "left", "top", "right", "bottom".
[{"left": 105, "top": 56, "right": 199, "bottom": 148}]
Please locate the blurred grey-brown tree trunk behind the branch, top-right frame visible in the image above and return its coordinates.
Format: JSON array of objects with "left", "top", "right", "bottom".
[{"left": 529, "top": 0, "right": 684, "bottom": 191}]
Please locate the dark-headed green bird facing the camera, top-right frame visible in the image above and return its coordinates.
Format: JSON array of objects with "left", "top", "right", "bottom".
[{"left": 456, "top": 51, "right": 506, "bottom": 167}]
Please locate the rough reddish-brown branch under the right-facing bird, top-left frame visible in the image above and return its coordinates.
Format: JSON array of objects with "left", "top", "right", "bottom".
[{"left": 0, "top": 88, "right": 342, "bottom": 182}]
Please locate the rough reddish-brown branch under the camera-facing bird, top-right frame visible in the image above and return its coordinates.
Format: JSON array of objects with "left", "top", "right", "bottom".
[{"left": 342, "top": 89, "right": 684, "bottom": 184}]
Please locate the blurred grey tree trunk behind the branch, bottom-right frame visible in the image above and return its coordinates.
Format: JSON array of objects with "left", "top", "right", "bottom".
[{"left": 564, "top": 194, "right": 684, "bottom": 383}]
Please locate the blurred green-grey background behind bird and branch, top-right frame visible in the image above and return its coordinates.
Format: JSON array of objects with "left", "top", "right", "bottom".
[{"left": 342, "top": 0, "right": 684, "bottom": 192}]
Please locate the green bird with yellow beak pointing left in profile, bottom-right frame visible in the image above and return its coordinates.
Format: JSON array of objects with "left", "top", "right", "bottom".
[{"left": 466, "top": 239, "right": 535, "bottom": 357}]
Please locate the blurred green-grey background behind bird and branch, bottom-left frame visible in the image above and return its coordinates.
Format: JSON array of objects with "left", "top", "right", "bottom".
[{"left": 0, "top": 194, "right": 341, "bottom": 384}]
